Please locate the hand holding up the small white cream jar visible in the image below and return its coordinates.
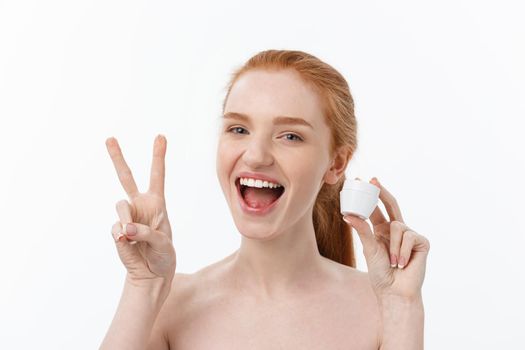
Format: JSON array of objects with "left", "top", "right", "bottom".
[{"left": 343, "top": 178, "right": 430, "bottom": 300}]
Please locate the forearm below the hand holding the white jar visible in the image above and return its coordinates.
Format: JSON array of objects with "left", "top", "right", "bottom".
[{"left": 379, "top": 296, "right": 425, "bottom": 350}]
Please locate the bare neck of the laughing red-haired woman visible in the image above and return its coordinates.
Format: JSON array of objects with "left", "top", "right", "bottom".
[{"left": 226, "top": 215, "right": 326, "bottom": 298}]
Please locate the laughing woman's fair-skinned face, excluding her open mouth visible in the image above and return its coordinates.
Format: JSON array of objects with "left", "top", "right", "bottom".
[{"left": 216, "top": 70, "right": 344, "bottom": 240}]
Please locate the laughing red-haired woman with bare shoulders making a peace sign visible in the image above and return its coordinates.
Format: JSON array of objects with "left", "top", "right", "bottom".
[{"left": 101, "top": 50, "right": 430, "bottom": 350}]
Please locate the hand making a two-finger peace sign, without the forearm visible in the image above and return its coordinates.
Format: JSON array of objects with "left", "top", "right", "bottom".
[{"left": 106, "top": 135, "right": 176, "bottom": 282}]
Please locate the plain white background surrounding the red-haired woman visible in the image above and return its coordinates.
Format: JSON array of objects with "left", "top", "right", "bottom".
[{"left": 0, "top": 0, "right": 525, "bottom": 349}]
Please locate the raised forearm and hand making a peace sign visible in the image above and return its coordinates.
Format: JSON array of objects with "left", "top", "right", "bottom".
[{"left": 100, "top": 135, "right": 177, "bottom": 350}]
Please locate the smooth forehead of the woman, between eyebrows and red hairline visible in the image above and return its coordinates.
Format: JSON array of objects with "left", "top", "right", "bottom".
[{"left": 224, "top": 69, "right": 323, "bottom": 126}]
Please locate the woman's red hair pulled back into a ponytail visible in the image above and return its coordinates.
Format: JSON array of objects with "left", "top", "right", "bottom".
[{"left": 222, "top": 50, "right": 357, "bottom": 267}]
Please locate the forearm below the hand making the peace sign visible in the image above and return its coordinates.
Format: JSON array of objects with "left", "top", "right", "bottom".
[{"left": 100, "top": 278, "right": 171, "bottom": 350}]
